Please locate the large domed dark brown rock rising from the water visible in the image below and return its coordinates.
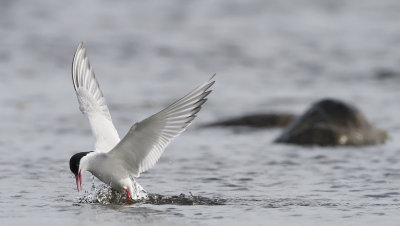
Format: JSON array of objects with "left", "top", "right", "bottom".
[{"left": 275, "top": 99, "right": 387, "bottom": 146}]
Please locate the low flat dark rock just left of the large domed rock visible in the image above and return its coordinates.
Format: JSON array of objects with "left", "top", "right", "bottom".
[{"left": 205, "top": 113, "right": 295, "bottom": 128}]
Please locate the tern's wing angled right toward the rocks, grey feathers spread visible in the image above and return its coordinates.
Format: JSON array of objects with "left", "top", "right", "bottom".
[{"left": 109, "top": 76, "right": 215, "bottom": 177}]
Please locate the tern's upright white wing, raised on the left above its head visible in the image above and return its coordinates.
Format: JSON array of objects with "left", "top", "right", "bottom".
[{"left": 72, "top": 42, "right": 120, "bottom": 152}]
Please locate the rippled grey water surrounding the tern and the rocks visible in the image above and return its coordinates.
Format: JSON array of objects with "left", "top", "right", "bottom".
[{"left": 0, "top": 0, "right": 400, "bottom": 225}]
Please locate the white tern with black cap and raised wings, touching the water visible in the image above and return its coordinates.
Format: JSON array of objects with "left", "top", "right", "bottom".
[{"left": 69, "top": 43, "right": 215, "bottom": 199}]
